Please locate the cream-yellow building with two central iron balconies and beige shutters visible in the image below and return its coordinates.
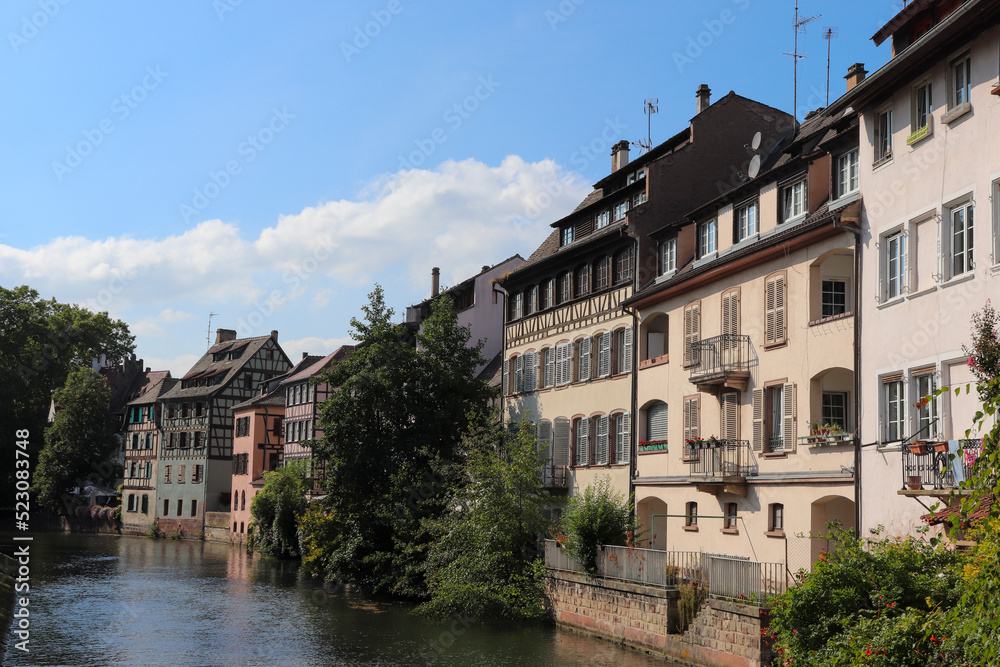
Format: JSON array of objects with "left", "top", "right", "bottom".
[{"left": 626, "top": 108, "right": 859, "bottom": 570}]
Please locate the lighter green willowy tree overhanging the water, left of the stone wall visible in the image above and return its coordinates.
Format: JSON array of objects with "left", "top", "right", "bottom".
[{"left": 418, "top": 421, "right": 546, "bottom": 619}]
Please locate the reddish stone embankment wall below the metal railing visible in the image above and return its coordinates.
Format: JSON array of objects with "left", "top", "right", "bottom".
[{"left": 545, "top": 571, "right": 770, "bottom": 667}]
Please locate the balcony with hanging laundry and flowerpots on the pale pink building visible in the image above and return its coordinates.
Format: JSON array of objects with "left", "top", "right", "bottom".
[{"left": 900, "top": 440, "right": 983, "bottom": 496}]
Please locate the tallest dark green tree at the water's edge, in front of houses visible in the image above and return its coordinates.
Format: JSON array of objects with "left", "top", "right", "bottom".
[{"left": 307, "top": 286, "right": 493, "bottom": 597}]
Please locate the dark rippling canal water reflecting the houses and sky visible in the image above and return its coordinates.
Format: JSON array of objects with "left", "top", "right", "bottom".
[{"left": 3, "top": 534, "right": 671, "bottom": 667}]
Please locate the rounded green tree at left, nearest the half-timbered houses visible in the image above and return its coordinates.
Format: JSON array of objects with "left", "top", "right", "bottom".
[{"left": 34, "top": 368, "right": 118, "bottom": 513}]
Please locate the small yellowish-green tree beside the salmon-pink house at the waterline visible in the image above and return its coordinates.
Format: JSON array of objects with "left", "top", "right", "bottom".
[{"left": 247, "top": 461, "right": 311, "bottom": 558}]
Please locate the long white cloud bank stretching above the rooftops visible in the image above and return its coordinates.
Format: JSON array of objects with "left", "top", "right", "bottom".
[{"left": 0, "top": 156, "right": 590, "bottom": 316}]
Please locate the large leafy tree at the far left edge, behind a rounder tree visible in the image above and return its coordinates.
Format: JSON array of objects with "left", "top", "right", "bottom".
[{"left": 0, "top": 286, "right": 135, "bottom": 498}]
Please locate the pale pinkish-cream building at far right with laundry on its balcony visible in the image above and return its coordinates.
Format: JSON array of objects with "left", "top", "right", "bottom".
[{"left": 832, "top": 0, "right": 1000, "bottom": 535}]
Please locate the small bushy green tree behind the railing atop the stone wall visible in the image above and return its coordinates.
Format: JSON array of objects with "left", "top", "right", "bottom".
[{"left": 563, "top": 476, "right": 639, "bottom": 572}]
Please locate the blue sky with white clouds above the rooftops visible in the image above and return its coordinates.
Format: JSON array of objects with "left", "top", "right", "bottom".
[{"left": 0, "top": 0, "right": 903, "bottom": 377}]
